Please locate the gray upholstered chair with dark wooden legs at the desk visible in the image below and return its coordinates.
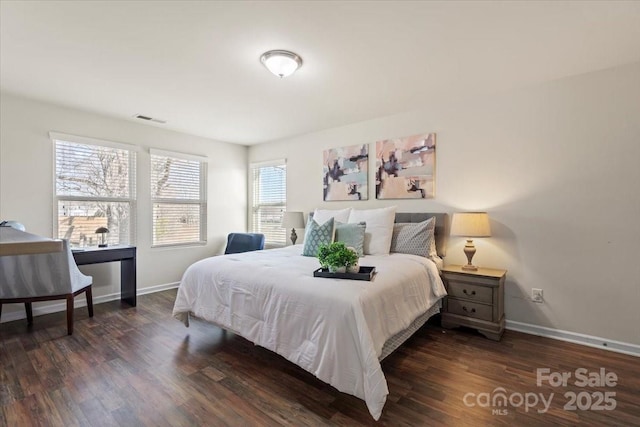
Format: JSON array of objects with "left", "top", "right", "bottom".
[{"left": 0, "top": 240, "right": 93, "bottom": 335}]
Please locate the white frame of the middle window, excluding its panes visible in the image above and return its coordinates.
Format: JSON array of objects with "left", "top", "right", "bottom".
[{"left": 149, "top": 148, "right": 209, "bottom": 248}]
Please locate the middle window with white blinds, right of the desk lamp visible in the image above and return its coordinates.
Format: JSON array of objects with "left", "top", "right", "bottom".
[{"left": 151, "top": 149, "right": 207, "bottom": 246}]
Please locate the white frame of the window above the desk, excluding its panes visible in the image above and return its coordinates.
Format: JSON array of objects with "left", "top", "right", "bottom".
[{"left": 49, "top": 131, "right": 140, "bottom": 247}]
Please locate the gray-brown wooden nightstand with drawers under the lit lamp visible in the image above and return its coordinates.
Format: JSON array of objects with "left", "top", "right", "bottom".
[{"left": 442, "top": 265, "right": 507, "bottom": 341}]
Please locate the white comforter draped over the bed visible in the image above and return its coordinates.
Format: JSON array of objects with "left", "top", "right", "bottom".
[{"left": 173, "top": 245, "right": 446, "bottom": 420}]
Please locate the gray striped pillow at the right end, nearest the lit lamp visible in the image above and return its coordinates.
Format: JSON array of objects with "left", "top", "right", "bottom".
[{"left": 391, "top": 217, "right": 437, "bottom": 258}]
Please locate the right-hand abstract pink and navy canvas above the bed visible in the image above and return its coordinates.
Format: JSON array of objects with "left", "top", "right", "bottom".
[{"left": 376, "top": 133, "right": 436, "bottom": 199}]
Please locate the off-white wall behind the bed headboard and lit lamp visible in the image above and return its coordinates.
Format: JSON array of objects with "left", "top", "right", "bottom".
[{"left": 249, "top": 63, "right": 640, "bottom": 345}]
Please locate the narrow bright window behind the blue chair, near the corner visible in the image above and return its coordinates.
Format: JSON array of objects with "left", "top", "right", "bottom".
[{"left": 249, "top": 160, "right": 287, "bottom": 245}]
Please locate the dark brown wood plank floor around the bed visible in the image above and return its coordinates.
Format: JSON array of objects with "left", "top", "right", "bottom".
[{"left": 0, "top": 291, "right": 640, "bottom": 426}]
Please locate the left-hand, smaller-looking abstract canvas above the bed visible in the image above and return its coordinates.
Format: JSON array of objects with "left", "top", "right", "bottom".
[{"left": 322, "top": 144, "right": 369, "bottom": 201}]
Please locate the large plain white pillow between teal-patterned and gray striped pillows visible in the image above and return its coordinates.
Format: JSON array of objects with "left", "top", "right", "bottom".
[{"left": 349, "top": 206, "right": 397, "bottom": 255}]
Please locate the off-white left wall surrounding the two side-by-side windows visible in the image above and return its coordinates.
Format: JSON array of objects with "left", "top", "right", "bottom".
[{"left": 0, "top": 93, "right": 248, "bottom": 319}]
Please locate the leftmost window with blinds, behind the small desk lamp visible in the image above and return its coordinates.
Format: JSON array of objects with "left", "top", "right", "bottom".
[{"left": 49, "top": 132, "right": 136, "bottom": 246}]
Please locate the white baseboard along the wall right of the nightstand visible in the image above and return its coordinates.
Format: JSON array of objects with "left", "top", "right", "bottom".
[{"left": 506, "top": 320, "right": 640, "bottom": 357}]
